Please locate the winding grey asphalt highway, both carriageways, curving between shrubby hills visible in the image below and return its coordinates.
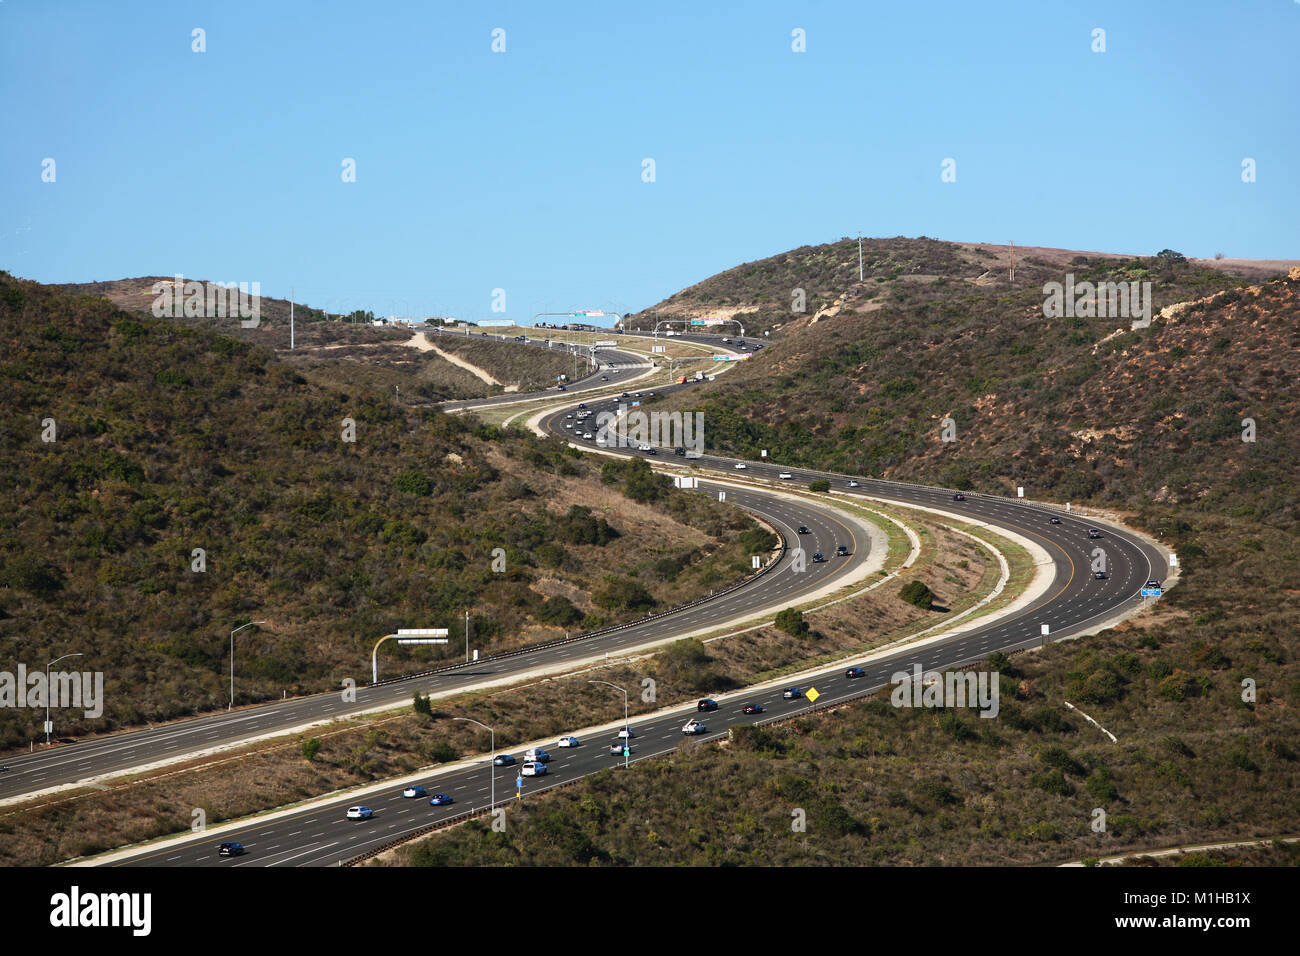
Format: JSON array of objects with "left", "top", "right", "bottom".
[{"left": 0, "top": 332, "right": 1167, "bottom": 865}]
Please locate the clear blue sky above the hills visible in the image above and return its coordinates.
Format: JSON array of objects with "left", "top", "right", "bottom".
[{"left": 0, "top": 0, "right": 1300, "bottom": 320}]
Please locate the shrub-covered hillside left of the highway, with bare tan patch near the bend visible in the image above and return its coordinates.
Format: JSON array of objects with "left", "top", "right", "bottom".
[{"left": 0, "top": 273, "right": 755, "bottom": 748}]
